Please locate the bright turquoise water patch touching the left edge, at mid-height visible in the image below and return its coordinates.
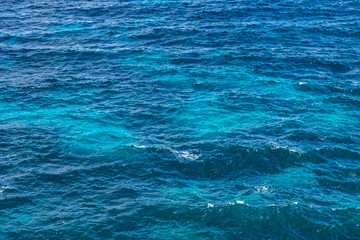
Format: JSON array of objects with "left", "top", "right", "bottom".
[{"left": 1, "top": 93, "right": 134, "bottom": 155}]
